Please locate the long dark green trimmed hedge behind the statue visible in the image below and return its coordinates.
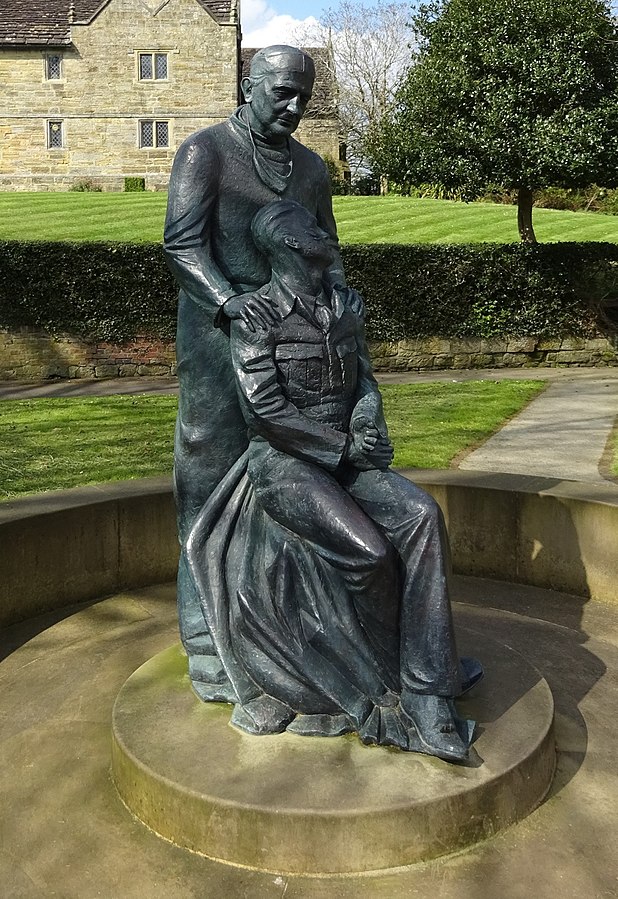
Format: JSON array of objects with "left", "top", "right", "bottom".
[{"left": 0, "top": 241, "right": 618, "bottom": 343}]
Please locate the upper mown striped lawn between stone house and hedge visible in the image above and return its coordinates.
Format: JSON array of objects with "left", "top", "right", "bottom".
[{"left": 0, "top": 192, "right": 618, "bottom": 243}]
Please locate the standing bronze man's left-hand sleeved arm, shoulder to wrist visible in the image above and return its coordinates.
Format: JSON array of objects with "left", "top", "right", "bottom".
[{"left": 163, "top": 134, "right": 237, "bottom": 313}]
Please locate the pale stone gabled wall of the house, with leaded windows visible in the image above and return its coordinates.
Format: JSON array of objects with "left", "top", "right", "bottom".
[{"left": 0, "top": 0, "right": 238, "bottom": 190}]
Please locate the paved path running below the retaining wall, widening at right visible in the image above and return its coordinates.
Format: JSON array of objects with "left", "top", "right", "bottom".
[{"left": 0, "top": 368, "right": 618, "bottom": 489}]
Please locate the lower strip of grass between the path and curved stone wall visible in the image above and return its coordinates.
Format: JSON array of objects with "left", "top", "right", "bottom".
[{"left": 0, "top": 381, "right": 543, "bottom": 499}]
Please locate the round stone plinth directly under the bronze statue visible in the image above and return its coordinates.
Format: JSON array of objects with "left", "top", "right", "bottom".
[{"left": 112, "top": 631, "right": 555, "bottom": 874}]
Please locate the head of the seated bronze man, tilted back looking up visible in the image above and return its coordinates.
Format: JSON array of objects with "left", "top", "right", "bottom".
[{"left": 251, "top": 200, "right": 334, "bottom": 274}]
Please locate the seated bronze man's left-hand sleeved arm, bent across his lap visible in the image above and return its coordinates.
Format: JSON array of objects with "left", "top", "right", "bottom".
[{"left": 230, "top": 320, "right": 348, "bottom": 471}]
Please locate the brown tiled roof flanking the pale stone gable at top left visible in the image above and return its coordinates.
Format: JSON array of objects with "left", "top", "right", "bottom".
[{"left": 0, "top": 0, "right": 237, "bottom": 47}]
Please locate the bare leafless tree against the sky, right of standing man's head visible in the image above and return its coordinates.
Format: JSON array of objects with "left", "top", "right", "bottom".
[{"left": 297, "top": 0, "right": 411, "bottom": 186}]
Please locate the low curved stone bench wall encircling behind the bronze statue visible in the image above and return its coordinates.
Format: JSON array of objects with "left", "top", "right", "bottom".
[{"left": 0, "top": 470, "right": 618, "bottom": 627}]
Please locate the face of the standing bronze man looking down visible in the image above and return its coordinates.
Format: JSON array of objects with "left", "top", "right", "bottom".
[{"left": 243, "top": 70, "right": 313, "bottom": 142}]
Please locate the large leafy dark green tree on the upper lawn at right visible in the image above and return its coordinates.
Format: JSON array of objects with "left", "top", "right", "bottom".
[{"left": 370, "top": 0, "right": 618, "bottom": 242}]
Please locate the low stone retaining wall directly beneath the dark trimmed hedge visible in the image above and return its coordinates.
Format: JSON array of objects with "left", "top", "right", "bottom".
[{"left": 0, "top": 328, "right": 618, "bottom": 381}]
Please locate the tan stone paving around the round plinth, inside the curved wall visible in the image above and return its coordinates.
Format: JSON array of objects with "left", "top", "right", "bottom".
[{"left": 0, "top": 578, "right": 618, "bottom": 899}]
